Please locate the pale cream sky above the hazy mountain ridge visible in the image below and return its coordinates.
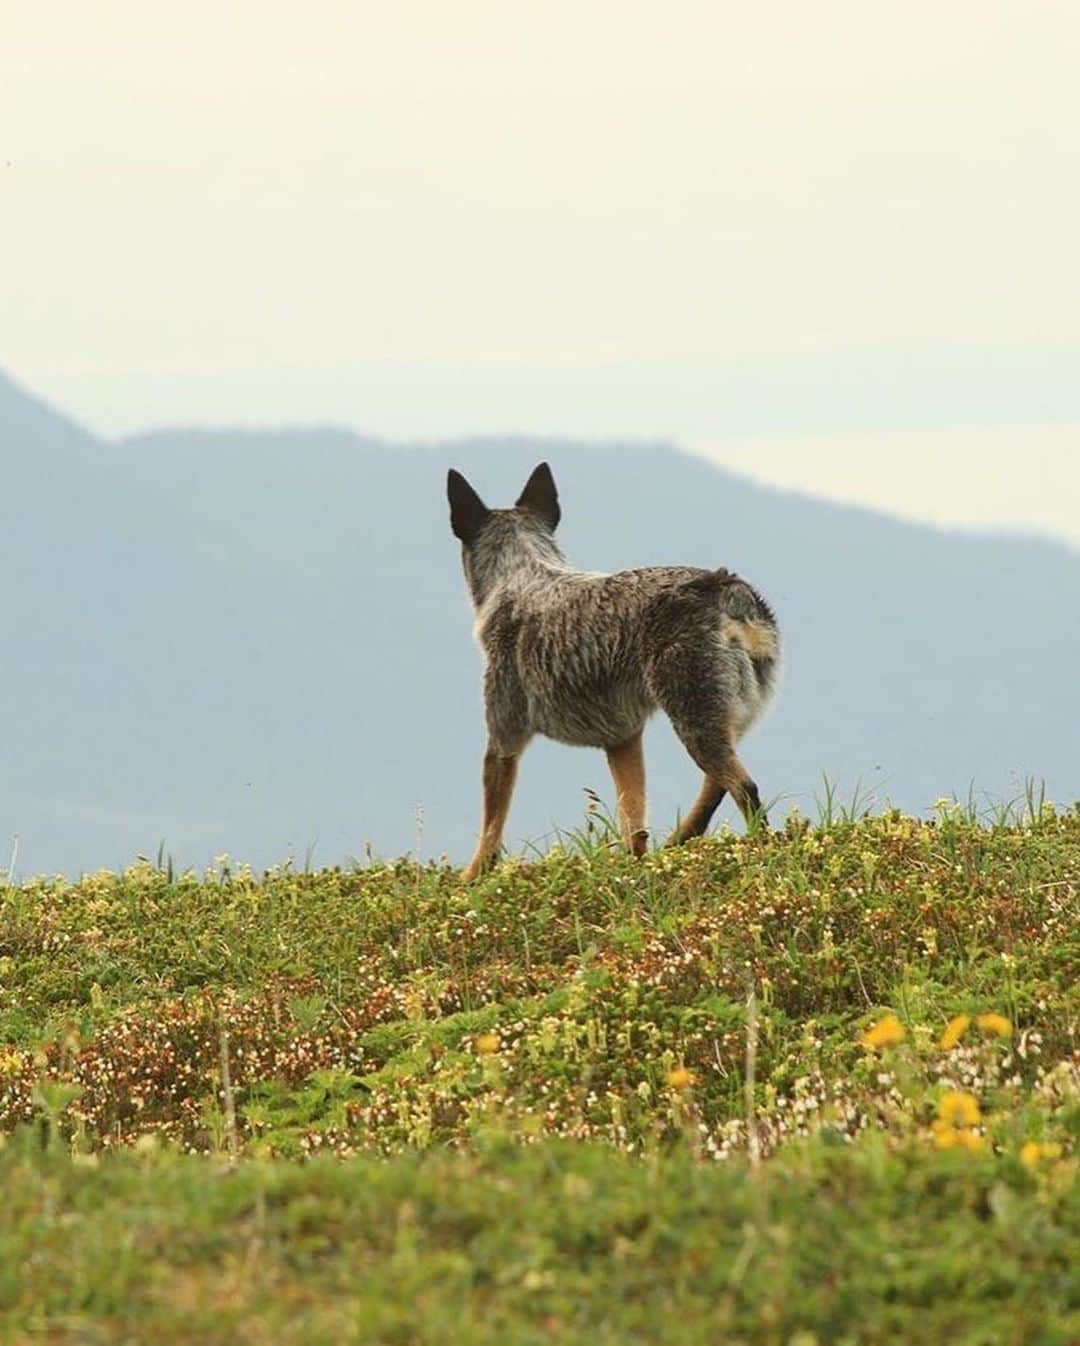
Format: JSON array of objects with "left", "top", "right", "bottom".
[{"left": 0, "top": 0, "right": 1080, "bottom": 542}]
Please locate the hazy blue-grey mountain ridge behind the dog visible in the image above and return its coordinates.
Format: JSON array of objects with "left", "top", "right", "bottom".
[{"left": 0, "top": 376, "right": 1080, "bottom": 874}]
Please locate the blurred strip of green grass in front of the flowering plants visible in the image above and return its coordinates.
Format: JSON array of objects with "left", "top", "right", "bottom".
[{"left": 0, "top": 1135, "right": 1080, "bottom": 1346}]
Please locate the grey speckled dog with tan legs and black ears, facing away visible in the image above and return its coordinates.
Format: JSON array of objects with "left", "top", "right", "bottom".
[{"left": 447, "top": 463, "right": 780, "bottom": 879}]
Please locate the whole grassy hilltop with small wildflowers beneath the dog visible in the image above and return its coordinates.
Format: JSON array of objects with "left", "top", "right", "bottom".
[{"left": 0, "top": 806, "right": 1080, "bottom": 1346}]
